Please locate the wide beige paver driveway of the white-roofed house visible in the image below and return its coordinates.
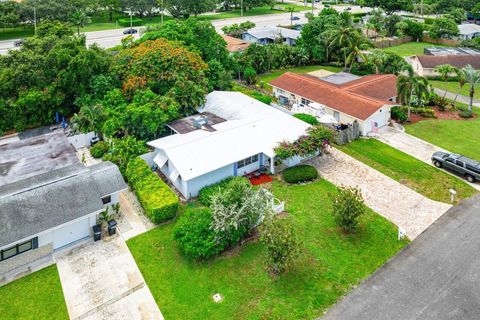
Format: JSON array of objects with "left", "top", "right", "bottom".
[{"left": 308, "top": 148, "right": 451, "bottom": 240}]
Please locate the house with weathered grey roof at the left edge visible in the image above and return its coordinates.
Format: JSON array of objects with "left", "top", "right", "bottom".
[{"left": 0, "top": 132, "right": 127, "bottom": 281}]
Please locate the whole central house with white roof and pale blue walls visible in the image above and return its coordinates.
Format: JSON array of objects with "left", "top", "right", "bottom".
[{"left": 148, "top": 91, "right": 310, "bottom": 199}]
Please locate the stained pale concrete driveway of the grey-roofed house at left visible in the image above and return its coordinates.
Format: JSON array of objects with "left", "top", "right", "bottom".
[{"left": 55, "top": 235, "right": 163, "bottom": 320}]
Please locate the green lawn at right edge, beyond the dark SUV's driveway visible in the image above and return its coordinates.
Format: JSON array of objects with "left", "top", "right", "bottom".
[{"left": 405, "top": 108, "right": 480, "bottom": 160}]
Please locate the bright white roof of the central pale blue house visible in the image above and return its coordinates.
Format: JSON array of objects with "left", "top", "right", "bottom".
[{"left": 148, "top": 91, "right": 309, "bottom": 180}]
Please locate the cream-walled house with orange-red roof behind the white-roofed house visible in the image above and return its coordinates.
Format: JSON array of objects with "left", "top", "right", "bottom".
[{"left": 270, "top": 72, "right": 397, "bottom": 136}]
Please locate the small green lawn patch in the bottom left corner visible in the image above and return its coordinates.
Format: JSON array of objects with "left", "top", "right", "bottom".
[{"left": 0, "top": 265, "right": 68, "bottom": 320}]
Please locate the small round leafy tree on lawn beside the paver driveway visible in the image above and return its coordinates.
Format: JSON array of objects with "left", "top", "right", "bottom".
[{"left": 330, "top": 187, "right": 366, "bottom": 232}]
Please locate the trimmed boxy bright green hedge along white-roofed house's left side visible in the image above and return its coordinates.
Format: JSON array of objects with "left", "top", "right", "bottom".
[{"left": 125, "top": 158, "right": 178, "bottom": 223}]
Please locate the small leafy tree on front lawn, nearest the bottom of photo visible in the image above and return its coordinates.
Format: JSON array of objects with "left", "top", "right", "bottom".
[{"left": 260, "top": 218, "right": 301, "bottom": 274}]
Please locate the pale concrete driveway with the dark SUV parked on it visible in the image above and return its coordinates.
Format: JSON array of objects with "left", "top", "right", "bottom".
[{"left": 374, "top": 127, "right": 480, "bottom": 190}]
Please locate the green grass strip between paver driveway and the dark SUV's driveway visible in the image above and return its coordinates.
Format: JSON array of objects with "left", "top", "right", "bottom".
[{"left": 339, "top": 139, "right": 477, "bottom": 203}]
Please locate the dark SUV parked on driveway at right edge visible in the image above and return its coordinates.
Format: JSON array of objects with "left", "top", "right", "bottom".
[{"left": 432, "top": 151, "right": 480, "bottom": 182}]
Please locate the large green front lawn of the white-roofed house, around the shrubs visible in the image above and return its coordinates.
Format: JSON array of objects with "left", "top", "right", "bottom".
[{"left": 127, "top": 180, "right": 407, "bottom": 320}]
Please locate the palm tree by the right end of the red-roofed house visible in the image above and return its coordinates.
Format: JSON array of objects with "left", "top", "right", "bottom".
[{"left": 397, "top": 67, "right": 430, "bottom": 121}]
